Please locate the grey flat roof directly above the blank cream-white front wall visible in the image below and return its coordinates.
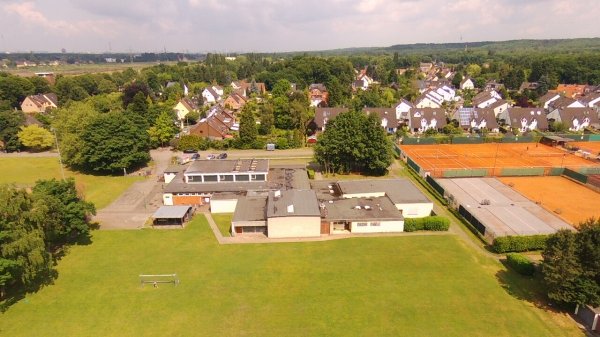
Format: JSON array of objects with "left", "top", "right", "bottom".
[{"left": 267, "top": 190, "right": 321, "bottom": 218}]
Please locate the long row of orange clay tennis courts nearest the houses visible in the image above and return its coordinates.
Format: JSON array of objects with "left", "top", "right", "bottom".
[{"left": 400, "top": 143, "right": 600, "bottom": 177}]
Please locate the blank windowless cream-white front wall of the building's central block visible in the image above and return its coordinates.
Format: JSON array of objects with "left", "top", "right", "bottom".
[{"left": 267, "top": 216, "right": 321, "bottom": 238}]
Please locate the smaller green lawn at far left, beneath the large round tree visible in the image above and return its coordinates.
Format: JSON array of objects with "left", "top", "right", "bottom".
[{"left": 0, "top": 157, "right": 144, "bottom": 209}]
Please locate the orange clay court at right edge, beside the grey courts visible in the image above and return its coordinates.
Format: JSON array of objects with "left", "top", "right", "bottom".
[{"left": 498, "top": 177, "right": 600, "bottom": 226}]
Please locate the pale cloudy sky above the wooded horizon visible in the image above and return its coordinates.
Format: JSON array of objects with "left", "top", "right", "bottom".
[{"left": 0, "top": 0, "right": 600, "bottom": 52}]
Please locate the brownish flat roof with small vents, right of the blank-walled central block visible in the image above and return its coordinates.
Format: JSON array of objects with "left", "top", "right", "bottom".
[{"left": 321, "top": 196, "right": 404, "bottom": 221}]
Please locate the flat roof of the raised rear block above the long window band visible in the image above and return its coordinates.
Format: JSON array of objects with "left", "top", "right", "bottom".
[{"left": 185, "top": 159, "right": 269, "bottom": 174}]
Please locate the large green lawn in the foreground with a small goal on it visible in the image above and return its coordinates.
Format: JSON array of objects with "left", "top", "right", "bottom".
[{"left": 0, "top": 215, "right": 583, "bottom": 337}]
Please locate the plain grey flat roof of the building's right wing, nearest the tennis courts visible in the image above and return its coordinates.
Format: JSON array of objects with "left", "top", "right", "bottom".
[{"left": 337, "top": 179, "right": 431, "bottom": 204}]
